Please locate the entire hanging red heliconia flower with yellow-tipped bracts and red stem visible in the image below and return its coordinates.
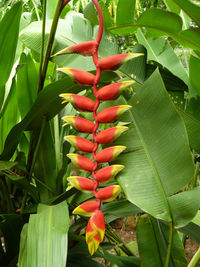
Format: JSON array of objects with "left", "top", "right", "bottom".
[{"left": 55, "top": 0, "right": 142, "bottom": 255}]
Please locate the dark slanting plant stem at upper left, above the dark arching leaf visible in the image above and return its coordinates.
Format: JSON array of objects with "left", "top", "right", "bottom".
[{"left": 38, "top": 0, "right": 63, "bottom": 93}]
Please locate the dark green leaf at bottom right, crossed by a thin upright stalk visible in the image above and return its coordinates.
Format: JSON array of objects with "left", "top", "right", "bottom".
[{"left": 137, "top": 215, "right": 187, "bottom": 267}]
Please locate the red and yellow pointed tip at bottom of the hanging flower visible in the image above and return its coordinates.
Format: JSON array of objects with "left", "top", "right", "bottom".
[{"left": 86, "top": 210, "right": 105, "bottom": 255}]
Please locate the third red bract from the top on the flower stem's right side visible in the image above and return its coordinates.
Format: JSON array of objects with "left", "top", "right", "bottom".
[{"left": 97, "top": 105, "right": 131, "bottom": 123}]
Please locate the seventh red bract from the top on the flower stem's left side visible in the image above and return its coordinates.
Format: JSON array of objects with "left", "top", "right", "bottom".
[{"left": 67, "top": 176, "right": 95, "bottom": 192}]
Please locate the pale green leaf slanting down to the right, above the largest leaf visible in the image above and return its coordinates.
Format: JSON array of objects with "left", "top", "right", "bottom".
[{"left": 136, "top": 29, "right": 189, "bottom": 85}]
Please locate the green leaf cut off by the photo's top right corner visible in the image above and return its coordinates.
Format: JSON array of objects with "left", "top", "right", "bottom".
[{"left": 173, "top": 0, "right": 200, "bottom": 26}]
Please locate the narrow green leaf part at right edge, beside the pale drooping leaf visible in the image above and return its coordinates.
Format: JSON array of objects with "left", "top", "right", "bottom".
[{"left": 189, "top": 55, "right": 200, "bottom": 95}]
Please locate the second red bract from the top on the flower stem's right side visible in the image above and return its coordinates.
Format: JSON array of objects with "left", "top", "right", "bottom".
[{"left": 97, "top": 81, "right": 135, "bottom": 101}]
